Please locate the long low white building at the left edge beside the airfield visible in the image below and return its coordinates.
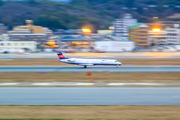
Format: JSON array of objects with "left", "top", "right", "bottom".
[{"left": 0, "top": 41, "right": 37, "bottom": 52}]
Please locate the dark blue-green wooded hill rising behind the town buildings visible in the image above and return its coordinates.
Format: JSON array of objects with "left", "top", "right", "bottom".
[{"left": 0, "top": 0, "right": 180, "bottom": 30}]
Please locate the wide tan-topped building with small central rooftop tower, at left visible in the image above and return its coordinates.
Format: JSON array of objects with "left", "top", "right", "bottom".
[{"left": 9, "top": 20, "right": 48, "bottom": 44}]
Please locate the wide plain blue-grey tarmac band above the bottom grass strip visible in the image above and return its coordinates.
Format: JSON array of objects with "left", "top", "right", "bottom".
[{"left": 0, "top": 87, "right": 180, "bottom": 105}]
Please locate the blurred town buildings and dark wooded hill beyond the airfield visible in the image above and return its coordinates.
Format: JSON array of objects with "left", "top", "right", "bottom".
[{"left": 0, "top": 0, "right": 180, "bottom": 54}]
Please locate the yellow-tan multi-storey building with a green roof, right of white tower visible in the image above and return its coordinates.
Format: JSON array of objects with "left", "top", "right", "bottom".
[{"left": 129, "top": 23, "right": 150, "bottom": 48}]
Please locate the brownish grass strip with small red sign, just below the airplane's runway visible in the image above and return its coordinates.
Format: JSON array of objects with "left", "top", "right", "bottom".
[{"left": 0, "top": 73, "right": 180, "bottom": 83}]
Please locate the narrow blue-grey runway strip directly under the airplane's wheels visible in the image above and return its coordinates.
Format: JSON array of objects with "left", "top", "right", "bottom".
[{"left": 0, "top": 66, "right": 180, "bottom": 73}]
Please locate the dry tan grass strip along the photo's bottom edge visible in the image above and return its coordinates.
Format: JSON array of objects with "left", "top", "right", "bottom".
[{"left": 0, "top": 106, "right": 180, "bottom": 120}]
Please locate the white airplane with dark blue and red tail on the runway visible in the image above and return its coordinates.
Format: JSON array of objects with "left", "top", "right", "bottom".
[{"left": 57, "top": 52, "right": 122, "bottom": 68}]
